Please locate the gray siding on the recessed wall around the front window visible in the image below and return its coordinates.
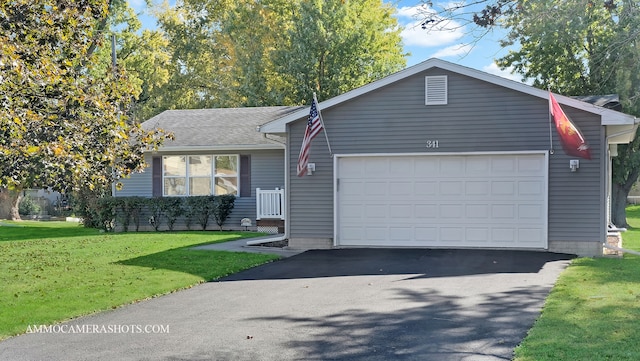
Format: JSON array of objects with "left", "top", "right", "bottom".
[{"left": 116, "top": 150, "right": 285, "bottom": 228}]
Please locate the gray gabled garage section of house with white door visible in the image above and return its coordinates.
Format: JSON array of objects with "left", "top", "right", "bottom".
[{"left": 258, "top": 59, "right": 637, "bottom": 256}]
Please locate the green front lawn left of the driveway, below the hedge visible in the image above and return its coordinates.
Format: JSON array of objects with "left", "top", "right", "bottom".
[{"left": 0, "top": 221, "right": 278, "bottom": 339}]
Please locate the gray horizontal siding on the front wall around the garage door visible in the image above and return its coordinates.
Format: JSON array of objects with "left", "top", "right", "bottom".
[{"left": 289, "top": 68, "right": 605, "bottom": 242}]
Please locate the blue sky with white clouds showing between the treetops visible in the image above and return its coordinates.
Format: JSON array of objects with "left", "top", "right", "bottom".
[{"left": 129, "top": 0, "right": 520, "bottom": 81}]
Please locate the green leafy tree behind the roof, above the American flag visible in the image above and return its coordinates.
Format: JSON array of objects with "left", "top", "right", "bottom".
[{"left": 273, "top": 0, "right": 406, "bottom": 104}]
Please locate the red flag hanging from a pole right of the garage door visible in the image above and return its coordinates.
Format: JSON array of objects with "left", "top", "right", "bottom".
[{"left": 549, "top": 92, "right": 591, "bottom": 159}]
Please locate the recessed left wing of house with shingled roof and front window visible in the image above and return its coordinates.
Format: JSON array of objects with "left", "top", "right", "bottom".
[{"left": 114, "top": 106, "right": 301, "bottom": 229}]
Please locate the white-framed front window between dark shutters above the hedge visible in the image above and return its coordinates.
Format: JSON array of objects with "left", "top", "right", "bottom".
[{"left": 162, "top": 155, "right": 239, "bottom": 196}]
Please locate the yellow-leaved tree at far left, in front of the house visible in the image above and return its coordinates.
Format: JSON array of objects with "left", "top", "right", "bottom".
[{"left": 0, "top": 0, "right": 169, "bottom": 218}]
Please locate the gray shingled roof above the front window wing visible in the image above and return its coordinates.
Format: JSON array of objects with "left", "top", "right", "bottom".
[{"left": 142, "top": 106, "right": 303, "bottom": 150}]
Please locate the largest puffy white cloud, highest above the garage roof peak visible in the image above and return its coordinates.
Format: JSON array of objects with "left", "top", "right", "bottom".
[{"left": 396, "top": 6, "right": 464, "bottom": 47}]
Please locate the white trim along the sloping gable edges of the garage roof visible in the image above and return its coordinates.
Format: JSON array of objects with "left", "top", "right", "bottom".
[{"left": 260, "top": 58, "right": 636, "bottom": 133}]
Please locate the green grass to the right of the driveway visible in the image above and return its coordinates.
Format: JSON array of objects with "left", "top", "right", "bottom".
[{"left": 515, "top": 206, "right": 640, "bottom": 361}]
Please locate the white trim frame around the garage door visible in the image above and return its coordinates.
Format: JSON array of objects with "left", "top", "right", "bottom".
[{"left": 333, "top": 150, "right": 550, "bottom": 250}]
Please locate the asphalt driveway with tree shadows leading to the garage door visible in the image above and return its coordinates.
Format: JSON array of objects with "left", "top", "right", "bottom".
[{"left": 0, "top": 249, "right": 571, "bottom": 361}]
